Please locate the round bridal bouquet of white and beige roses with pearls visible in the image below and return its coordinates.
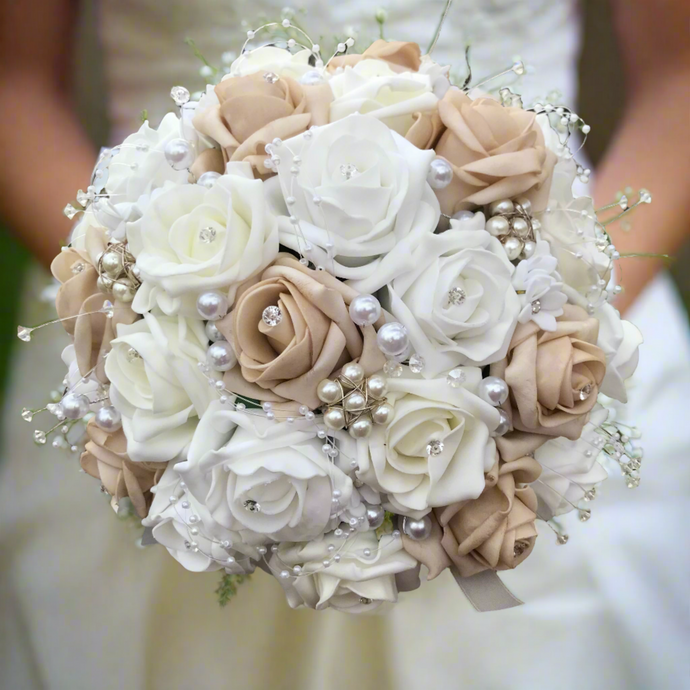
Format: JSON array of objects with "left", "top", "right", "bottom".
[{"left": 19, "top": 20, "right": 650, "bottom": 612}]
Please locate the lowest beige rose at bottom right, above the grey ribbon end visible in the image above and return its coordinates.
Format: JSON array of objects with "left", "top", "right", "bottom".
[{"left": 436, "top": 457, "right": 541, "bottom": 577}]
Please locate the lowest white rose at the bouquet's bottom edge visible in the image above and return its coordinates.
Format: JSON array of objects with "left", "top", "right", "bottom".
[{"left": 270, "top": 531, "right": 417, "bottom": 613}]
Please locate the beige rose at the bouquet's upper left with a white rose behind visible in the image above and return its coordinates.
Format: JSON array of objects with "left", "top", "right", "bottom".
[{"left": 194, "top": 72, "right": 332, "bottom": 175}]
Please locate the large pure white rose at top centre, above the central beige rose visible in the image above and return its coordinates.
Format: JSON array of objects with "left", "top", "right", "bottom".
[{"left": 267, "top": 115, "right": 440, "bottom": 293}]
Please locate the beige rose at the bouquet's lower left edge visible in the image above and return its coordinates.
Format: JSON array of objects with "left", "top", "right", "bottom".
[{"left": 80, "top": 420, "right": 168, "bottom": 518}]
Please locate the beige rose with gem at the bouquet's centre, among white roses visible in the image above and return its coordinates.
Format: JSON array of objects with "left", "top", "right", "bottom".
[{"left": 218, "top": 255, "right": 385, "bottom": 408}]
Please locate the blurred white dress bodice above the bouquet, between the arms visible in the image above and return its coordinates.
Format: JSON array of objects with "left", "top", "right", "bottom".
[{"left": 100, "top": 0, "right": 580, "bottom": 141}]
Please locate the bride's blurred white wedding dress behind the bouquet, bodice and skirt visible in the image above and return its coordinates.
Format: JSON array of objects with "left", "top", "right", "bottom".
[{"left": 0, "top": 0, "right": 690, "bottom": 690}]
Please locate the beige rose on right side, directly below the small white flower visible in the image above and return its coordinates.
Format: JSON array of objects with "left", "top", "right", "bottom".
[{"left": 491, "top": 304, "right": 606, "bottom": 452}]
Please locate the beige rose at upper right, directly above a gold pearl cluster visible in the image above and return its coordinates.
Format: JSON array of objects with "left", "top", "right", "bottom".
[{"left": 436, "top": 89, "right": 556, "bottom": 215}]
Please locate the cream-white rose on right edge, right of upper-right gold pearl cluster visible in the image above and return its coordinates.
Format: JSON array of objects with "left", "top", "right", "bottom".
[{"left": 539, "top": 158, "right": 612, "bottom": 307}]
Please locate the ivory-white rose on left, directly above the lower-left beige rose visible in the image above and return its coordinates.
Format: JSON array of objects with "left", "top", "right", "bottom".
[{"left": 105, "top": 314, "right": 215, "bottom": 462}]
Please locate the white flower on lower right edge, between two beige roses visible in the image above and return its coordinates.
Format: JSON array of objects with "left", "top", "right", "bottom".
[{"left": 532, "top": 404, "right": 609, "bottom": 517}]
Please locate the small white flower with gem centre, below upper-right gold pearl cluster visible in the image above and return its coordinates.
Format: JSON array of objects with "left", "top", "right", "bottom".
[{"left": 513, "top": 240, "right": 568, "bottom": 331}]
